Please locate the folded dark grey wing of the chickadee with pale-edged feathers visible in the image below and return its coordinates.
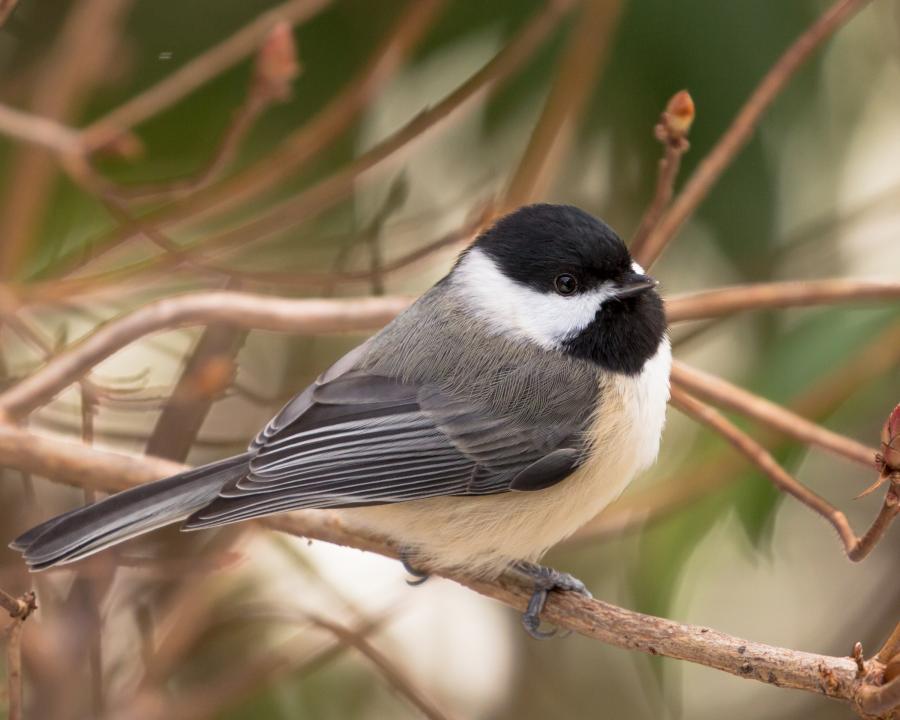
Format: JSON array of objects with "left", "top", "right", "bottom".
[{"left": 187, "top": 353, "right": 582, "bottom": 527}]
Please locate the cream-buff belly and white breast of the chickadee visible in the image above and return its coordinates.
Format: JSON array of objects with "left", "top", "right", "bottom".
[{"left": 342, "top": 343, "right": 671, "bottom": 576}]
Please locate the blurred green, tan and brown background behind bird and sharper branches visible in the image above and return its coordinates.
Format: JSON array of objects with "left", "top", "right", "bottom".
[{"left": 0, "top": 0, "right": 900, "bottom": 720}]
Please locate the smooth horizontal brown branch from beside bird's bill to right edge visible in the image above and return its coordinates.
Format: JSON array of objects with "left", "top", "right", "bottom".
[{"left": 666, "top": 278, "right": 900, "bottom": 322}]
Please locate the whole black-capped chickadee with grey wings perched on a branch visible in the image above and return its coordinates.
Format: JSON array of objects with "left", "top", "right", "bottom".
[{"left": 11, "top": 204, "right": 671, "bottom": 637}]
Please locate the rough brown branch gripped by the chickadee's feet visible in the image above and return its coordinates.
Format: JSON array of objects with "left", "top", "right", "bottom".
[{"left": 0, "top": 427, "right": 888, "bottom": 716}]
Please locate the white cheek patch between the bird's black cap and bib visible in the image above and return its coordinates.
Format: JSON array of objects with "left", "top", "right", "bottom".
[{"left": 453, "top": 249, "right": 613, "bottom": 348}]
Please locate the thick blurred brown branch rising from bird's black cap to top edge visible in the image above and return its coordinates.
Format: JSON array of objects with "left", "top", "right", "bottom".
[{"left": 503, "top": 0, "right": 621, "bottom": 211}]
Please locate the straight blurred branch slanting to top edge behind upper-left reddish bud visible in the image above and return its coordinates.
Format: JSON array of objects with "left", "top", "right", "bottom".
[{"left": 82, "top": 0, "right": 331, "bottom": 152}]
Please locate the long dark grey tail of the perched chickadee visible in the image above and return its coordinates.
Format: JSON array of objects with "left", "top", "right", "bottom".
[{"left": 10, "top": 453, "right": 251, "bottom": 570}]
